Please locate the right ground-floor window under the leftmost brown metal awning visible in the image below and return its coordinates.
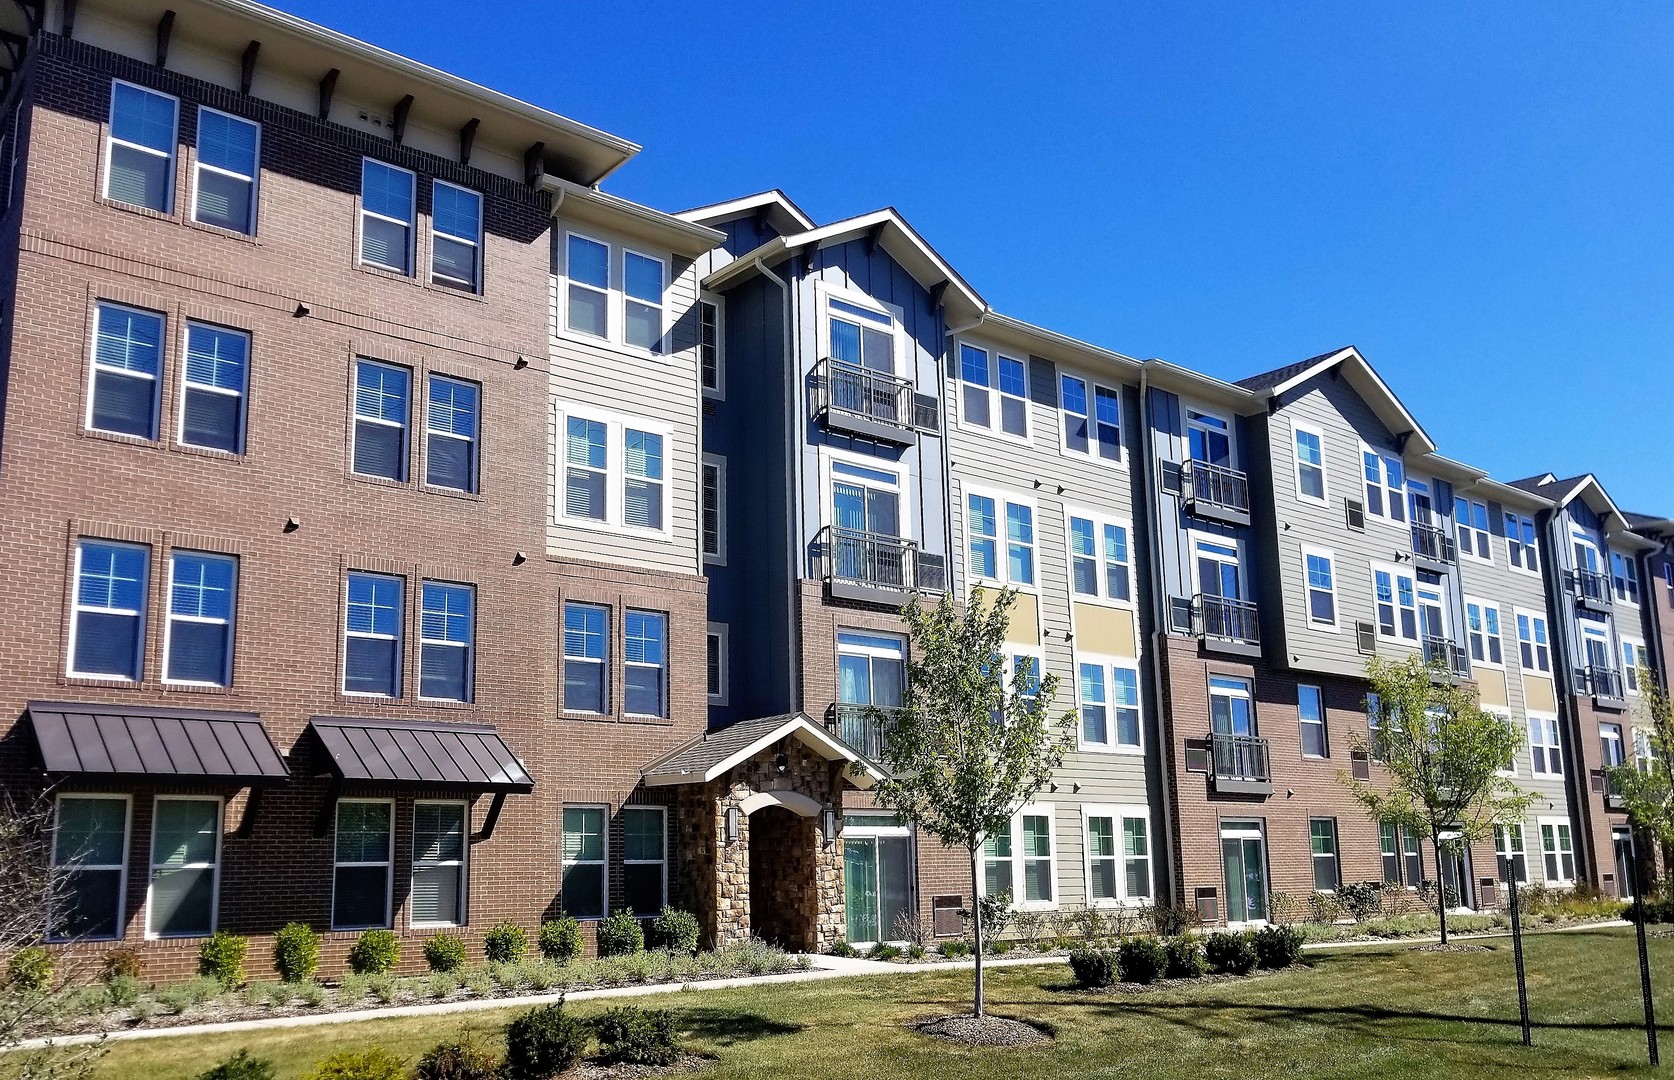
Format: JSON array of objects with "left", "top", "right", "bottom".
[{"left": 146, "top": 795, "right": 221, "bottom": 938}]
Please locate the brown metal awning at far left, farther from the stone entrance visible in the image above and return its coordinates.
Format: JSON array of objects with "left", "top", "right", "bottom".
[{"left": 28, "top": 702, "right": 290, "bottom": 784}]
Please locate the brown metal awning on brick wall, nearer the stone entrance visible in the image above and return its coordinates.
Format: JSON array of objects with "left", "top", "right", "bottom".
[{"left": 310, "top": 717, "right": 534, "bottom": 794}]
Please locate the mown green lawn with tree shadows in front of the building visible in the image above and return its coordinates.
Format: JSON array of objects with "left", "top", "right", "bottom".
[{"left": 78, "top": 929, "right": 1674, "bottom": 1080}]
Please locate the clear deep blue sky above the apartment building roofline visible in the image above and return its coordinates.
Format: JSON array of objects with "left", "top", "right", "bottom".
[{"left": 281, "top": 0, "right": 1674, "bottom": 514}]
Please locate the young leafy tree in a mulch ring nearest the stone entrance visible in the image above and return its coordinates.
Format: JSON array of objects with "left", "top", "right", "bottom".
[{"left": 870, "top": 589, "right": 1075, "bottom": 1016}]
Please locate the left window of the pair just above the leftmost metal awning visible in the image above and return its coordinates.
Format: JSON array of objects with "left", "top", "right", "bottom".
[{"left": 69, "top": 539, "right": 151, "bottom": 681}]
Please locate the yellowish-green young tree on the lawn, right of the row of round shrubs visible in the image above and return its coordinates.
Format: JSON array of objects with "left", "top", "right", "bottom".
[{"left": 1341, "top": 656, "right": 1533, "bottom": 944}]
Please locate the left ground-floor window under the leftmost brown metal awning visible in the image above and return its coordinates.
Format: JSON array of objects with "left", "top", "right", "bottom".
[{"left": 47, "top": 795, "right": 129, "bottom": 941}]
